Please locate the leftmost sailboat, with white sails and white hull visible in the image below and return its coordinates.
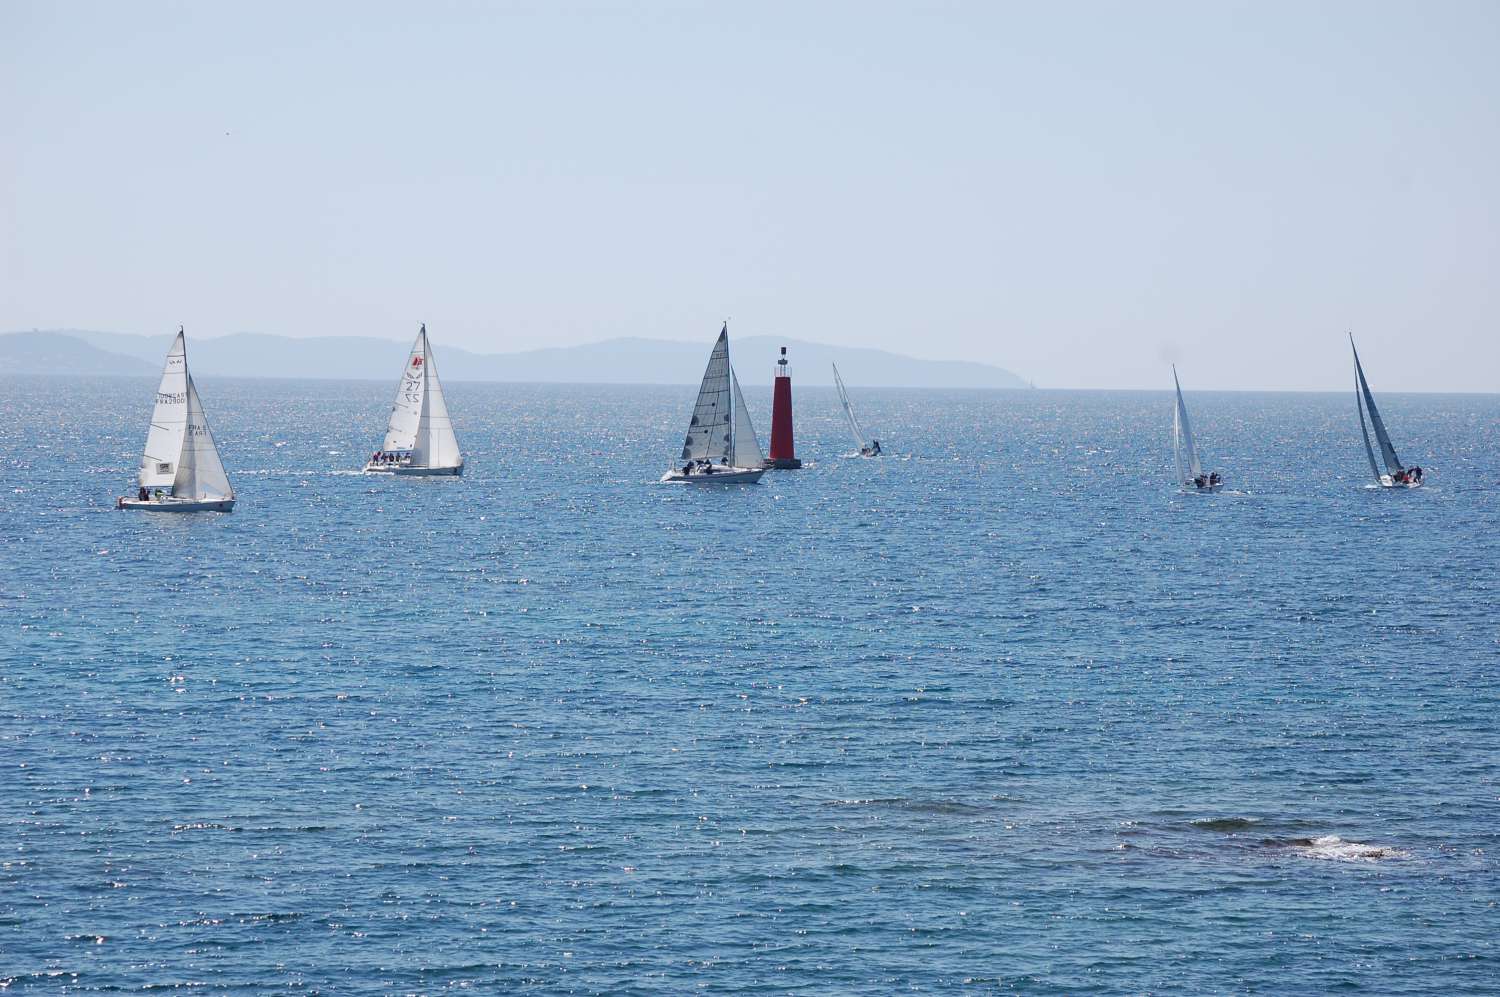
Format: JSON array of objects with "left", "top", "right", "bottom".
[{"left": 116, "top": 325, "right": 234, "bottom": 513}]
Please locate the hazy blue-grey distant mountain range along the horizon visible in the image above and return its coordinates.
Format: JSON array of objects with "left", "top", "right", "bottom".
[{"left": 0, "top": 328, "right": 1026, "bottom": 388}]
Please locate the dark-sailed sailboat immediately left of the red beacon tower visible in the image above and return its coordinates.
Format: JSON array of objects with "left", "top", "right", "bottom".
[{"left": 662, "top": 322, "right": 765, "bottom": 484}]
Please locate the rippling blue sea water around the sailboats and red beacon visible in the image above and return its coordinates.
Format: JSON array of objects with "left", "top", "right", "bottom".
[{"left": 0, "top": 378, "right": 1500, "bottom": 994}]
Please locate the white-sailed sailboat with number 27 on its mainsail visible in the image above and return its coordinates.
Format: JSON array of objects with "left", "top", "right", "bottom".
[{"left": 365, "top": 322, "right": 464, "bottom": 475}]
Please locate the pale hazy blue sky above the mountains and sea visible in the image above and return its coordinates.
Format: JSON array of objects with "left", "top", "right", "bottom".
[{"left": 0, "top": 0, "right": 1500, "bottom": 391}]
